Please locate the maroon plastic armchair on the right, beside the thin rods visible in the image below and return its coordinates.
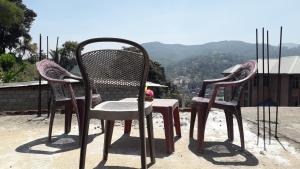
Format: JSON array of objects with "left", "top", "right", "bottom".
[{"left": 190, "top": 61, "right": 257, "bottom": 152}]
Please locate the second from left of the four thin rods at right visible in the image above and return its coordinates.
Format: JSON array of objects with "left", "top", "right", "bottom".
[{"left": 262, "top": 28, "right": 266, "bottom": 150}]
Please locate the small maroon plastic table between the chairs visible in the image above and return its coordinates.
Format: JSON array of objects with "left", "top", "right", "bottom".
[{"left": 122, "top": 98, "right": 181, "bottom": 153}]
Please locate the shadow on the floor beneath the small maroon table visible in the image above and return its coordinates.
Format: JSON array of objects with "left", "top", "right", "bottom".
[{"left": 108, "top": 134, "right": 178, "bottom": 158}]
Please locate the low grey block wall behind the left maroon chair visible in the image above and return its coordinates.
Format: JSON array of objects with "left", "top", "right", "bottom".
[{"left": 0, "top": 81, "right": 137, "bottom": 111}]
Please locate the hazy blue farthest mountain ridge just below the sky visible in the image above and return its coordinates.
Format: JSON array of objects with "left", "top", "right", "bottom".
[{"left": 142, "top": 41, "right": 300, "bottom": 66}]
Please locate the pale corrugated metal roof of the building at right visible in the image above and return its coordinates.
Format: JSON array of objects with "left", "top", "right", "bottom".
[{"left": 223, "top": 56, "right": 300, "bottom": 74}]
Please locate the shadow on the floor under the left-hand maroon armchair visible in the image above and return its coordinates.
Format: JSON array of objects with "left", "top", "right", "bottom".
[{"left": 15, "top": 133, "right": 100, "bottom": 155}]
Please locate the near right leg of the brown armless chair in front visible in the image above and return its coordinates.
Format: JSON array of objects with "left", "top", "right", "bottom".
[{"left": 139, "top": 117, "right": 147, "bottom": 169}]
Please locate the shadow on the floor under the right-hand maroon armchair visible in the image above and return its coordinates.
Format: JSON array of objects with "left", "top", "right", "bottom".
[{"left": 189, "top": 139, "right": 259, "bottom": 166}]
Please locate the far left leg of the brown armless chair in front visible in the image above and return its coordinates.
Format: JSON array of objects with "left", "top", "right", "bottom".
[{"left": 103, "top": 120, "right": 115, "bottom": 161}]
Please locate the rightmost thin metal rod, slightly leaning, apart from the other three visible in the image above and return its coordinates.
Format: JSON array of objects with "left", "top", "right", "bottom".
[{"left": 275, "top": 26, "right": 282, "bottom": 139}]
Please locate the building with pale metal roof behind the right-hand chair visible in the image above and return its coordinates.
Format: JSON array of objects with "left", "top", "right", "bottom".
[{"left": 223, "top": 56, "right": 300, "bottom": 106}]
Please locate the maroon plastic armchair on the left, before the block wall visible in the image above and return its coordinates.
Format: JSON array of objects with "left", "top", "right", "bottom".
[{"left": 36, "top": 59, "right": 104, "bottom": 141}]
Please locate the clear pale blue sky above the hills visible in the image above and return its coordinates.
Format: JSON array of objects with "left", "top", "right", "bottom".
[{"left": 23, "top": 0, "right": 300, "bottom": 48}]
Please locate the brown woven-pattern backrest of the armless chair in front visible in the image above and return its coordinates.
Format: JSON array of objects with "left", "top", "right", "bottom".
[{"left": 76, "top": 38, "right": 149, "bottom": 104}]
